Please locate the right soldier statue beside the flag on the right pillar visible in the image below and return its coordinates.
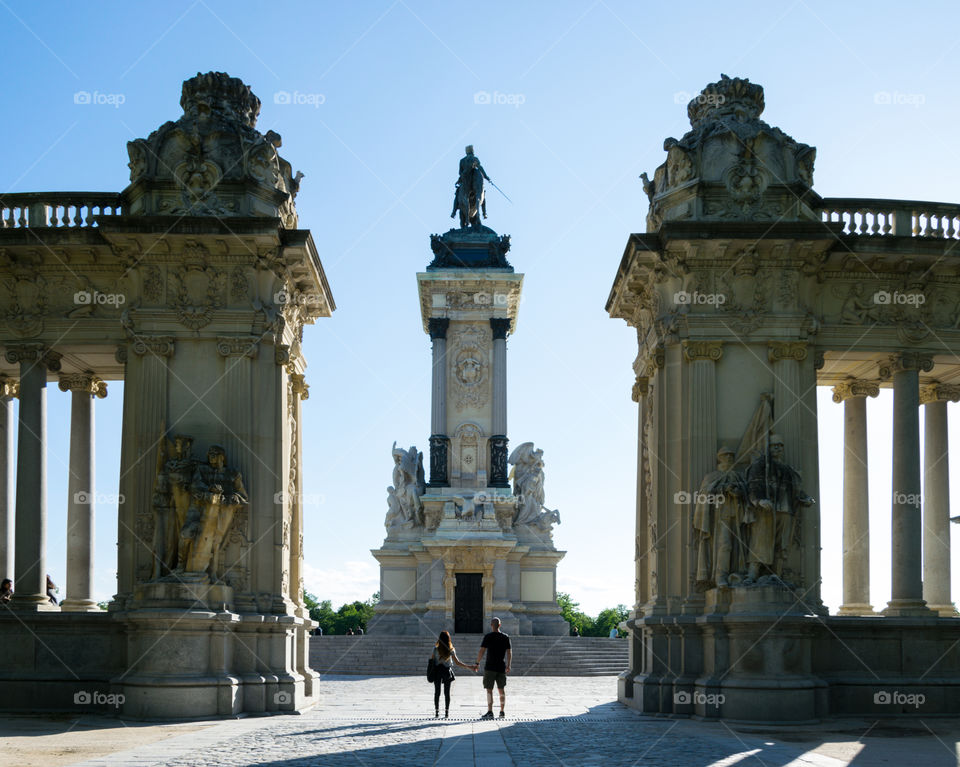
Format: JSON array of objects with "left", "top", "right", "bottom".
[{"left": 743, "top": 434, "right": 814, "bottom": 583}]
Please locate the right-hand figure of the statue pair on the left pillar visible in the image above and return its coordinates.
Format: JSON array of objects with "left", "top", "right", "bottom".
[{"left": 178, "top": 445, "right": 247, "bottom": 580}]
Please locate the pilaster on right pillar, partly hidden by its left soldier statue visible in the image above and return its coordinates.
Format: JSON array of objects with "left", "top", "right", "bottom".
[{"left": 681, "top": 340, "right": 723, "bottom": 612}]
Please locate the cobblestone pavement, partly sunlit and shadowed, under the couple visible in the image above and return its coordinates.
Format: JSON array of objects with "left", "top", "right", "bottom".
[{"left": 65, "top": 673, "right": 960, "bottom": 767}]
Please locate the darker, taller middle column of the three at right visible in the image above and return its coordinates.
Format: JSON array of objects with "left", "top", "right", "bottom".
[{"left": 880, "top": 352, "right": 933, "bottom": 616}]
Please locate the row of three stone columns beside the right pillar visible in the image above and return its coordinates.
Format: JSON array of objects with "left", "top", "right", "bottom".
[{"left": 833, "top": 352, "right": 960, "bottom": 616}]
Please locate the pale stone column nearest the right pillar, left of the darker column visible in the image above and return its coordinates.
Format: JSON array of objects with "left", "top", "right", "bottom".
[{"left": 833, "top": 378, "right": 880, "bottom": 615}]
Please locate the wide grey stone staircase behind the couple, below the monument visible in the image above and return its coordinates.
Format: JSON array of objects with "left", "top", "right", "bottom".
[{"left": 310, "top": 634, "right": 628, "bottom": 676}]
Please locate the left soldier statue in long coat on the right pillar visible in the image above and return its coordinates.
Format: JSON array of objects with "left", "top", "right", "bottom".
[{"left": 693, "top": 447, "right": 747, "bottom": 587}]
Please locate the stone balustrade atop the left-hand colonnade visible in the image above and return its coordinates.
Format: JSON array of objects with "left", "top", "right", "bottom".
[{"left": 0, "top": 192, "right": 121, "bottom": 229}]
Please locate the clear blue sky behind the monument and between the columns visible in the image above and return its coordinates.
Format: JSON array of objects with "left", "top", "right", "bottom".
[{"left": 0, "top": 0, "right": 960, "bottom": 613}]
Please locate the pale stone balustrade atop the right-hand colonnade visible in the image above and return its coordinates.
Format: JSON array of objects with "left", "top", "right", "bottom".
[{"left": 819, "top": 197, "right": 960, "bottom": 239}]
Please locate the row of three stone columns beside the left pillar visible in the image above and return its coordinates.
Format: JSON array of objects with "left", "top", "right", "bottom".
[{"left": 0, "top": 344, "right": 107, "bottom": 612}]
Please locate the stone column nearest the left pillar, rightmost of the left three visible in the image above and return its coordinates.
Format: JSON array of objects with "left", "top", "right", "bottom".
[{"left": 60, "top": 372, "right": 107, "bottom": 612}]
